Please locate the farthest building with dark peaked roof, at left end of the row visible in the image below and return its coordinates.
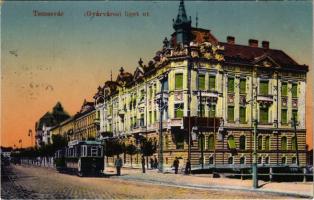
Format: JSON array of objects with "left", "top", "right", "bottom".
[{"left": 35, "top": 102, "right": 70, "bottom": 147}]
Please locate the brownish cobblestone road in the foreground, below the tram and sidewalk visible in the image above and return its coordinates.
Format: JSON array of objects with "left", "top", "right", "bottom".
[{"left": 1, "top": 166, "right": 304, "bottom": 199}]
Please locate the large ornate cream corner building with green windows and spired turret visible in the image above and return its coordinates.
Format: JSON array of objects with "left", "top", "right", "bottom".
[{"left": 94, "top": 1, "right": 308, "bottom": 168}]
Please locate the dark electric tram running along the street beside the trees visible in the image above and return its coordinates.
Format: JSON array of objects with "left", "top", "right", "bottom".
[{"left": 55, "top": 140, "right": 104, "bottom": 176}]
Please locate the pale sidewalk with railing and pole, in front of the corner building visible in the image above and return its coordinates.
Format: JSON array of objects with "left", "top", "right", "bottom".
[{"left": 105, "top": 167, "right": 313, "bottom": 198}]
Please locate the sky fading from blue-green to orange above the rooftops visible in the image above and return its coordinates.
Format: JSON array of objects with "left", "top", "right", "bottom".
[{"left": 1, "top": 1, "right": 313, "bottom": 147}]
